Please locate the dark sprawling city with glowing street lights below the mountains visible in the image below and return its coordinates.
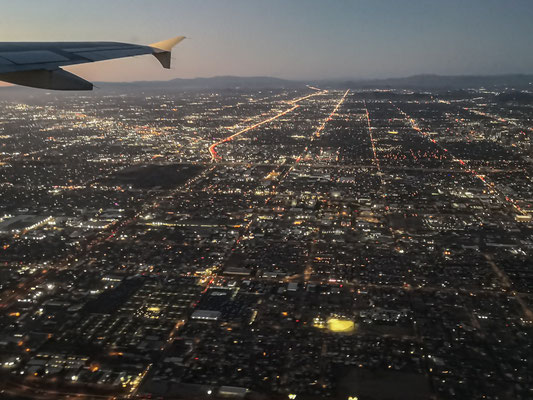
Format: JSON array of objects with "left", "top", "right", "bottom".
[{"left": 0, "top": 87, "right": 533, "bottom": 400}]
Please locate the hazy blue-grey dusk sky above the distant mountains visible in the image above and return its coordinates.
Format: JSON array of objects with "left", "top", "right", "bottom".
[{"left": 0, "top": 0, "right": 533, "bottom": 81}]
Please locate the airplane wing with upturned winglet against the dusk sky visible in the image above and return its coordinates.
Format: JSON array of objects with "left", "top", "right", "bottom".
[{"left": 0, "top": 36, "right": 185, "bottom": 90}]
